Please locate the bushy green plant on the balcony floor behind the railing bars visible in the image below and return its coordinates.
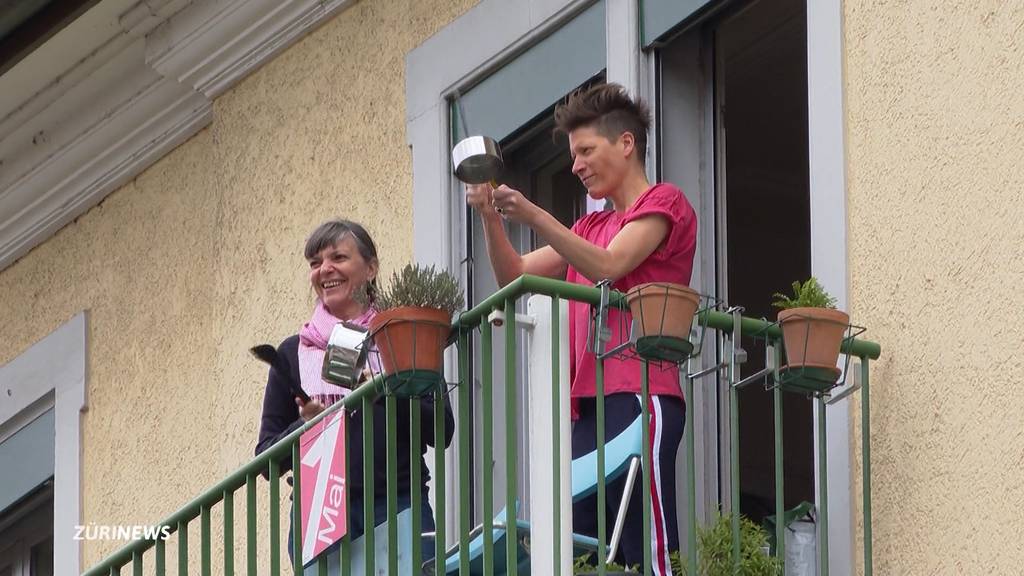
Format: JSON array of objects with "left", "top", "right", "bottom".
[{"left": 669, "top": 516, "right": 782, "bottom": 576}]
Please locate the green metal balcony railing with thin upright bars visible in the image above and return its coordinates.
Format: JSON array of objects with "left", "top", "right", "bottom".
[{"left": 85, "top": 276, "right": 881, "bottom": 576}]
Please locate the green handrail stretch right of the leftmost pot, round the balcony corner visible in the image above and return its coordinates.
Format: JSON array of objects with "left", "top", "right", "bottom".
[{"left": 455, "top": 274, "right": 882, "bottom": 360}]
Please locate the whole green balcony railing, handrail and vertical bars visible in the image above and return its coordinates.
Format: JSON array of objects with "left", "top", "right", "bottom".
[{"left": 84, "top": 275, "right": 881, "bottom": 576}]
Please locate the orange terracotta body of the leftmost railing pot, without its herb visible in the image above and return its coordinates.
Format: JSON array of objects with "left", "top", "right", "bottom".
[{"left": 370, "top": 306, "right": 452, "bottom": 374}]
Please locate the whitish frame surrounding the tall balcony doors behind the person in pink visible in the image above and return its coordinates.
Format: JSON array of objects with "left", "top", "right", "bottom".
[{"left": 406, "top": 0, "right": 854, "bottom": 575}]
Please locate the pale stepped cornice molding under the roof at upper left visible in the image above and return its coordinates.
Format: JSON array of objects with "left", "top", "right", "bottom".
[{"left": 0, "top": 0, "right": 354, "bottom": 270}]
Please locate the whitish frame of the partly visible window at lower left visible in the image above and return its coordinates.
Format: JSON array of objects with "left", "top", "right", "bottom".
[{"left": 0, "top": 313, "right": 87, "bottom": 574}]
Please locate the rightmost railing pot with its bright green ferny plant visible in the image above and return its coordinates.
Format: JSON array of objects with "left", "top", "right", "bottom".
[{"left": 772, "top": 276, "right": 850, "bottom": 381}]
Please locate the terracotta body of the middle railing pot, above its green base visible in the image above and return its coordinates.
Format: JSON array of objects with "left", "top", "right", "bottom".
[{"left": 626, "top": 282, "right": 700, "bottom": 340}]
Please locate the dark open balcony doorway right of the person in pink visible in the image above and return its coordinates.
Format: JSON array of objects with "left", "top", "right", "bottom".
[{"left": 657, "top": 0, "right": 815, "bottom": 522}]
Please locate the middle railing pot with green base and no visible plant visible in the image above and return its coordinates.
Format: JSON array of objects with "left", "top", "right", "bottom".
[{"left": 626, "top": 282, "right": 700, "bottom": 362}]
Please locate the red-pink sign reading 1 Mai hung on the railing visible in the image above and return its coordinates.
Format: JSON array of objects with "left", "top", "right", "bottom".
[{"left": 299, "top": 410, "right": 348, "bottom": 565}]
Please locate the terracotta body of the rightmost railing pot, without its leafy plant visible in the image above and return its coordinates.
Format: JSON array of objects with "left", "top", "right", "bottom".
[{"left": 778, "top": 307, "right": 850, "bottom": 369}]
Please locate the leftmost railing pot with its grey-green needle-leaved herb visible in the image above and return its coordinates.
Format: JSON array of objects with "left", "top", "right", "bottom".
[{"left": 370, "top": 264, "right": 464, "bottom": 389}]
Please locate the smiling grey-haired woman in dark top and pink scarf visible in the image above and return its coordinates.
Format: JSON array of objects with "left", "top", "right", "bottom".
[{"left": 256, "top": 219, "right": 455, "bottom": 568}]
